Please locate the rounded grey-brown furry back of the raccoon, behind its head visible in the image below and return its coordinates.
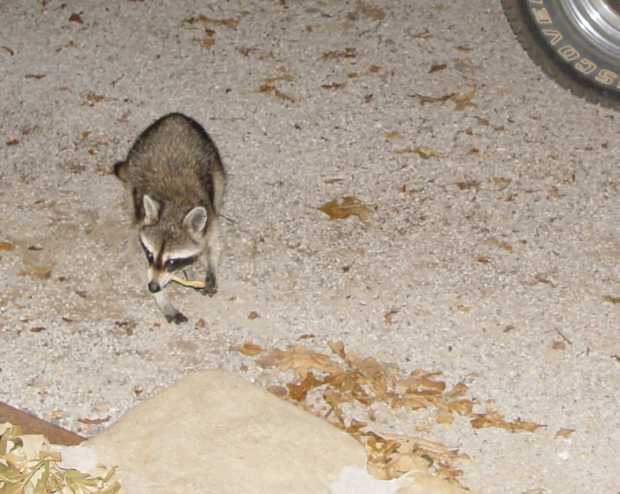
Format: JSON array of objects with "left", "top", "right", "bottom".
[{"left": 122, "top": 113, "right": 224, "bottom": 204}]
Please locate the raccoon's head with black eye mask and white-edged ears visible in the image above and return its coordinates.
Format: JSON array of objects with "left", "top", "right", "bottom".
[{"left": 139, "top": 195, "right": 207, "bottom": 293}]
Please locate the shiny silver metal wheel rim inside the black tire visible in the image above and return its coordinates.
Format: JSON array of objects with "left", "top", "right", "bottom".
[{"left": 560, "top": 0, "right": 620, "bottom": 60}]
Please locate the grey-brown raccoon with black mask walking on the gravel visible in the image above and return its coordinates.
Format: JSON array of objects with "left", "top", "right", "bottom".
[{"left": 114, "top": 113, "right": 226, "bottom": 324}]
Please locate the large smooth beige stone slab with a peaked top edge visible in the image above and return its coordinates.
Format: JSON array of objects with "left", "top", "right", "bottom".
[{"left": 61, "top": 370, "right": 465, "bottom": 494}]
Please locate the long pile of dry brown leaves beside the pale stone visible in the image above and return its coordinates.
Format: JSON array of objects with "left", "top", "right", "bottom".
[{"left": 239, "top": 342, "right": 542, "bottom": 484}]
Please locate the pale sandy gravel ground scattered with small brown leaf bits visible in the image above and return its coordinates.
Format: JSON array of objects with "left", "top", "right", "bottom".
[{"left": 0, "top": 0, "right": 620, "bottom": 494}]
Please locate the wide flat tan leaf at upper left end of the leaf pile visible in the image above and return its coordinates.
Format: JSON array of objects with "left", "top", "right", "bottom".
[{"left": 256, "top": 346, "right": 342, "bottom": 379}]
